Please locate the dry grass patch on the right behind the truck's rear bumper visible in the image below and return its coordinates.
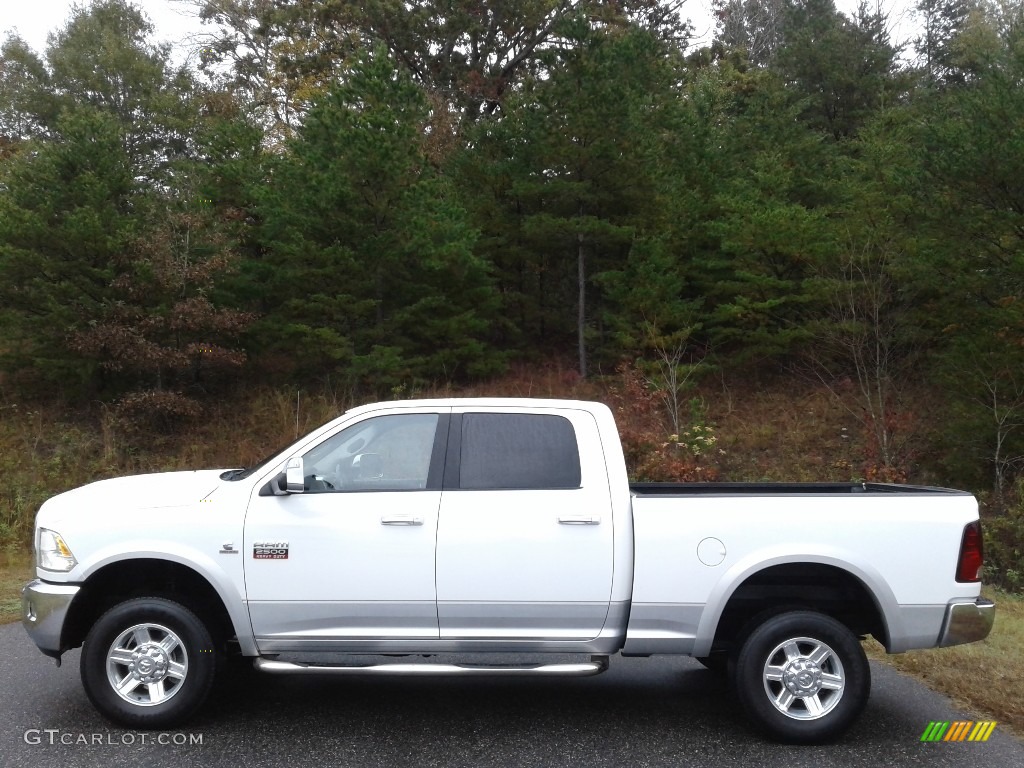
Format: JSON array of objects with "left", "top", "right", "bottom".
[{"left": 866, "top": 589, "right": 1024, "bottom": 737}]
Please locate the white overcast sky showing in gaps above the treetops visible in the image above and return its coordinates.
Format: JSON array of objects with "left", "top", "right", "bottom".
[{"left": 0, "top": 0, "right": 913, "bottom": 61}]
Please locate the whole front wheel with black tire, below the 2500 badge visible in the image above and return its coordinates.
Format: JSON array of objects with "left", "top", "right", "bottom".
[{"left": 81, "top": 597, "right": 217, "bottom": 729}]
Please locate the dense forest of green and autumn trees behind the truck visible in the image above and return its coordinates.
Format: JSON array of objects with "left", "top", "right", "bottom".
[{"left": 0, "top": 0, "right": 1024, "bottom": 587}]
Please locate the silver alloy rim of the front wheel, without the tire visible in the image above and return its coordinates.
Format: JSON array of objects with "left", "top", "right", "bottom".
[{"left": 106, "top": 624, "right": 188, "bottom": 707}]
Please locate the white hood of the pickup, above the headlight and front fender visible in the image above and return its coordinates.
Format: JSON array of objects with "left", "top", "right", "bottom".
[{"left": 39, "top": 469, "right": 224, "bottom": 524}]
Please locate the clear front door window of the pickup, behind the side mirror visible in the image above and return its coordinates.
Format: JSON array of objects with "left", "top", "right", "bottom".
[{"left": 302, "top": 414, "right": 438, "bottom": 494}]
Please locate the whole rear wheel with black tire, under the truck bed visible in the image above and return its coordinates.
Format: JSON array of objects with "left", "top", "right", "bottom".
[{"left": 734, "top": 610, "right": 871, "bottom": 744}]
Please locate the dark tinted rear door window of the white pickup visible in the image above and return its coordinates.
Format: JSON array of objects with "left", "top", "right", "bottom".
[{"left": 459, "top": 414, "right": 581, "bottom": 489}]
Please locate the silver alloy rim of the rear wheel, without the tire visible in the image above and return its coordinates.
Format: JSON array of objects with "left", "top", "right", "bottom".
[{"left": 764, "top": 637, "right": 846, "bottom": 720}]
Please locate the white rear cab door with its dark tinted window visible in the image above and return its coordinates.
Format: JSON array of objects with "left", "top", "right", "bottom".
[{"left": 436, "top": 407, "right": 612, "bottom": 641}]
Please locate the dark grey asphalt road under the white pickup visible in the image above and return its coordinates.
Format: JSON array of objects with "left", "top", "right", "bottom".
[{"left": 0, "top": 625, "right": 1024, "bottom": 768}]
